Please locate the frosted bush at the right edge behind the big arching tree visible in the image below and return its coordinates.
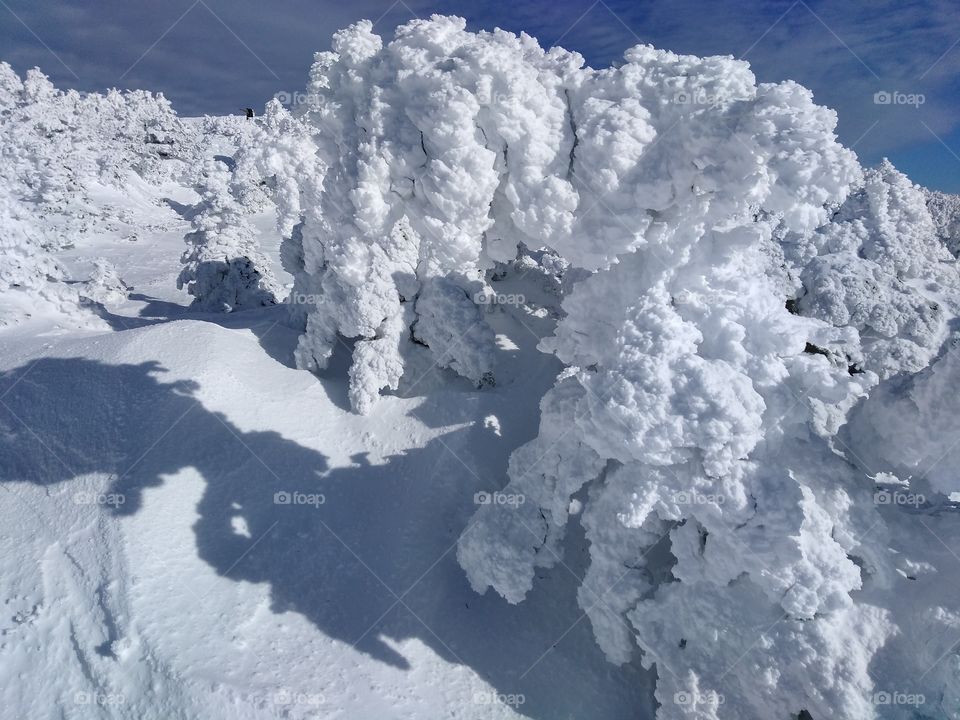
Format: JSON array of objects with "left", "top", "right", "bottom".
[{"left": 786, "top": 161, "right": 960, "bottom": 377}]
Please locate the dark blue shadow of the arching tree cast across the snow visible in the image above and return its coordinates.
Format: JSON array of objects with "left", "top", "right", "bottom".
[{"left": 0, "top": 358, "right": 652, "bottom": 720}]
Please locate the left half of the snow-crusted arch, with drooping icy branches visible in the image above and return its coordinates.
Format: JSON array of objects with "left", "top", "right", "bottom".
[{"left": 287, "top": 19, "right": 570, "bottom": 409}]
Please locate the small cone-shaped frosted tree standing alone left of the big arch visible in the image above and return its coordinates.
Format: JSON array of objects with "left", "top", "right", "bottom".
[{"left": 177, "top": 158, "right": 281, "bottom": 312}]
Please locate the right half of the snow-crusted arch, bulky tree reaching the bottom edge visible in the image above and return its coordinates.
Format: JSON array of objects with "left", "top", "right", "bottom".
[{"left": 448, "top": 38, "right": 892, "bottom": 717}]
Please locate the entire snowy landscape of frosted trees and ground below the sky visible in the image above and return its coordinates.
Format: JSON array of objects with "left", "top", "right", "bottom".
[{"left": 0, "top": 16, "right": 960, "bottom": 720}]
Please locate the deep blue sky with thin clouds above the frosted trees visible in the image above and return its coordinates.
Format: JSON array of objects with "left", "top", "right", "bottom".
[{"left": 0, "top": 0, "right": 960, "bottom": 193}]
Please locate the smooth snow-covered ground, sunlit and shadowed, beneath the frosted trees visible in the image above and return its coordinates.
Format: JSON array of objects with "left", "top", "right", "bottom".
[{"left": 0, "top": 172, "right": 652, "bottom": 719}]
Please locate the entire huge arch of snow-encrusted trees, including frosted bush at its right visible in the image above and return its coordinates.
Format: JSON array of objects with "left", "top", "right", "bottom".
[{"left": 268, "top": 17, "right": 957, "bottom": 718}]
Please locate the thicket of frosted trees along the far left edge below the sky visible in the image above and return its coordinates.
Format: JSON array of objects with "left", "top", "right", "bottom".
[{"left": 0, "top": 63, "right": 189, "bottom": 325}]
